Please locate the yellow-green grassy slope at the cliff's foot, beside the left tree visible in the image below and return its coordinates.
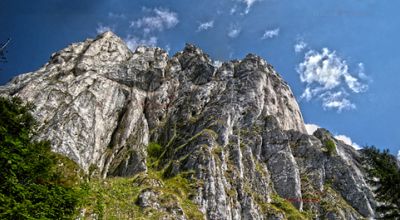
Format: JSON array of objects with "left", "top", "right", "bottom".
[{"left": 77, "top": 143, "right": 203, "bottom": 219}]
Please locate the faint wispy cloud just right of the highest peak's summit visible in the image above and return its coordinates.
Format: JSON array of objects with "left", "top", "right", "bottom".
[{"left": 130, "top": 8, "right": 179, "bottom": 34}]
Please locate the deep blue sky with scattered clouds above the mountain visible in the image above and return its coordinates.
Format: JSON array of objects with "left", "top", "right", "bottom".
[{"left": 0, "top": 0, "right": 400, "bottom": 154}]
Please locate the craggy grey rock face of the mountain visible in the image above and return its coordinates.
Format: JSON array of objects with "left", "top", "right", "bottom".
[{"left": 0, "top": 32, "right": 375, "bottom": 219}]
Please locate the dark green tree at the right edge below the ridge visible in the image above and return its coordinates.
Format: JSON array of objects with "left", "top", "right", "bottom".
[{"left": 363, "top": 146, "right": 400, "bottom": 219}]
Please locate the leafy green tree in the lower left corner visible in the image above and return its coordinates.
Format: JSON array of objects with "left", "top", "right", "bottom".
[{"left": 0, "top": 97, "right": 78, "bottom": 219}]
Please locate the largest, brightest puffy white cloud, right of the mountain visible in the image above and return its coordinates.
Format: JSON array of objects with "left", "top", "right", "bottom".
[{"left": 296, "top": 48, "right": 368, "bottom": 112}]
